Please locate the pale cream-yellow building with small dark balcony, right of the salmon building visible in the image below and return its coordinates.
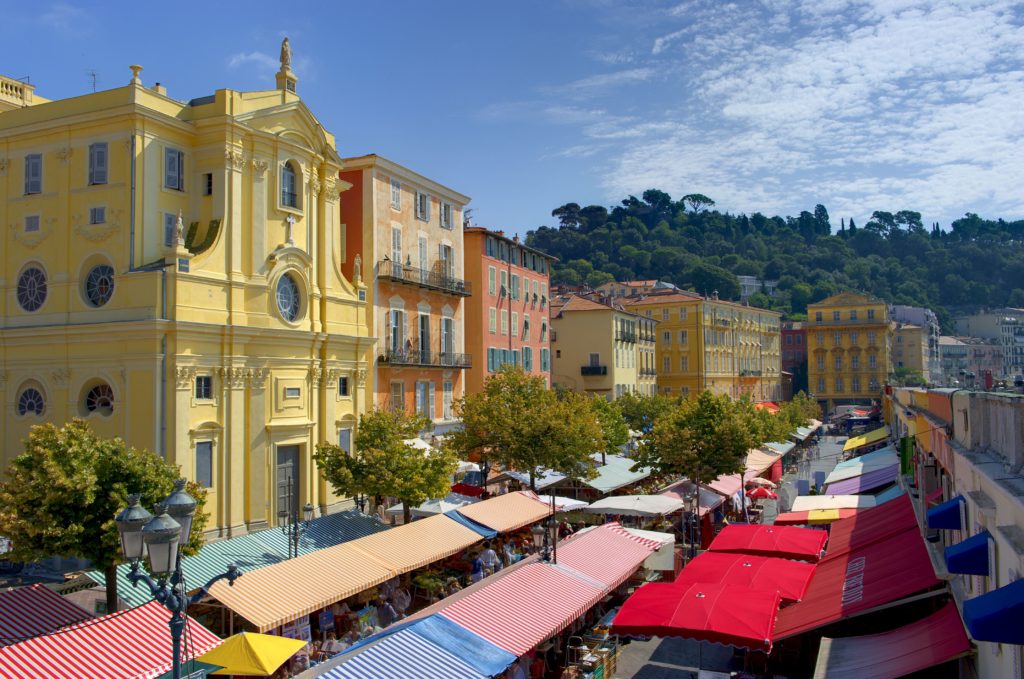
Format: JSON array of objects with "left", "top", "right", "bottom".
[{"left": 551, "top": 295, "right": 657, "bottom": 400}]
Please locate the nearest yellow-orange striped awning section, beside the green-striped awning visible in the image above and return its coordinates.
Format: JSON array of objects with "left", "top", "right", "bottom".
[{"left": 210, "top": 540, "right": 395, "bottom": 632}]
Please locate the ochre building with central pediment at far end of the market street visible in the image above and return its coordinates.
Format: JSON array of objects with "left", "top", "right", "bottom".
[{"left": 806, "top": 292, "right": 892, "bottom": 410}]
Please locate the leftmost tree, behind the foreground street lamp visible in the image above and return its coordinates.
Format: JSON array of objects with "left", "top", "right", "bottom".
[{"left": 0, "top": 419, "right": 206, "bottom": 611}]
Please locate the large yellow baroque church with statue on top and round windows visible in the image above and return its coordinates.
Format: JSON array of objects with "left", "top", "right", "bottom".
[{"left": 0, "top": 42, "right": 374, "bottom": 536}]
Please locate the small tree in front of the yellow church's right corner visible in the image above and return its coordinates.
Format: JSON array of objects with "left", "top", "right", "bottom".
[{"left": 313, "top": 409, "right": 459, "bottom": 523}]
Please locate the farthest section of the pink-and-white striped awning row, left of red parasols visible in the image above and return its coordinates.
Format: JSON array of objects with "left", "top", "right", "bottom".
[{"left": 558, "top": 523, "right": 662, "bottom": 589}]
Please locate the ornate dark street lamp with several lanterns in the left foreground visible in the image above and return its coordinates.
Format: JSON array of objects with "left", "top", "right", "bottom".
[{"left": 115, "top": 479, "right": 242, "bottom": 679}]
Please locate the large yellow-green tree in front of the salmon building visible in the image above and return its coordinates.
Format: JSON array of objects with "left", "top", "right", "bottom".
[{"left": 447, "top": 367, "right": 604, "bottom": 489}]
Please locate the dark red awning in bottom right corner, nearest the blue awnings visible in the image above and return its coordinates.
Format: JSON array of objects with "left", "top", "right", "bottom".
[{"left": 814, "top": 603, "right": 971, "bottom": 679}]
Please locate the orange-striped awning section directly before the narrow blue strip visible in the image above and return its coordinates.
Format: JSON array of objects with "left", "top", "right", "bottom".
[{"left": 351, "top": 516, "right": 483, "bottom": 574}]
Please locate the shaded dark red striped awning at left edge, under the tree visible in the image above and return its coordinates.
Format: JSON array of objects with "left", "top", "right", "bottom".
[{"left": 0, "top": 585, "right": 92, "bottom": 646}]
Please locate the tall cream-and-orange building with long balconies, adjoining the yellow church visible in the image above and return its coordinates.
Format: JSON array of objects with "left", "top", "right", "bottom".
[{"left": 340, "top": 155, "right": 472, "bottom": 431}]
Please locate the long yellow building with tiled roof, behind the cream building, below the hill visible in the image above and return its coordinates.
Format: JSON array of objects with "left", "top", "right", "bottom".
[{"left": 626, "top": 290, "right": 782, "bottom": 400}]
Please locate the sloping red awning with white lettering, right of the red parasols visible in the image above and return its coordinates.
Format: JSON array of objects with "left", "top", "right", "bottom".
[{"left": 775, "top": 519, "right": 939, "bottom": 641}]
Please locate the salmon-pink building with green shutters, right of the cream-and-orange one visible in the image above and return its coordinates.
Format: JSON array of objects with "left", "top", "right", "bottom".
[{"left": 464, "top": 226, "right": 556, "bottom": 393}]
